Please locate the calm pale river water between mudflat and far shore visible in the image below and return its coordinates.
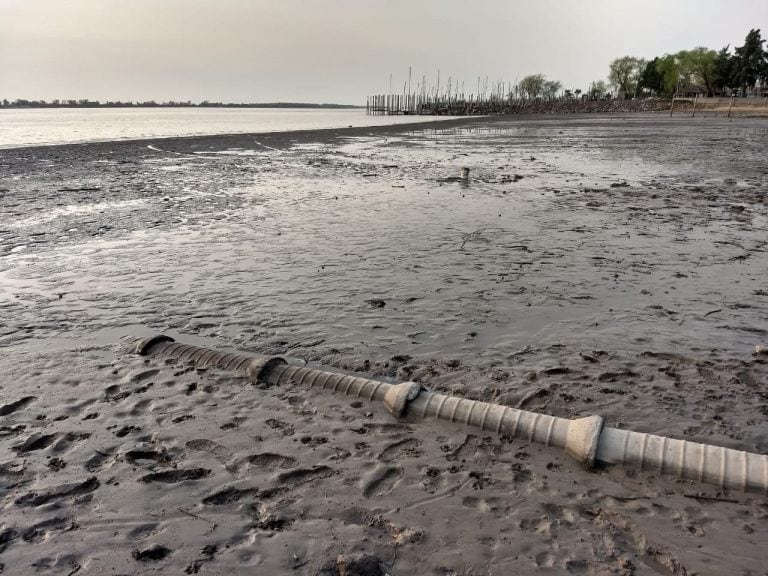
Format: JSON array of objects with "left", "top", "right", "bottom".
[{"left": 0, "top": 108, "right": 452, "bottom": 148}]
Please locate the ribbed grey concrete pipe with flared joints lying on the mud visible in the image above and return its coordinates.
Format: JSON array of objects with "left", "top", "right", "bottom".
[{"left": 134, "top": 336, "right": 768, "bottom": 495}]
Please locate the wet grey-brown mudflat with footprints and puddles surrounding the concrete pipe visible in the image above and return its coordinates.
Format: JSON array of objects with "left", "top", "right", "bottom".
[{"left": 0, "top": 115, "right": 768, "bottom": 575}]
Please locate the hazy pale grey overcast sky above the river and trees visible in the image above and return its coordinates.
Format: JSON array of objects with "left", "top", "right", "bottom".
[{"left": 0, "top": 0, "right": 768, "bottom": 104}]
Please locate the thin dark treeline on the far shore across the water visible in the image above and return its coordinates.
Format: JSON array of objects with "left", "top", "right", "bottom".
[{"left": 0, "top": 99, "right": 359, "bottom": 108}]
